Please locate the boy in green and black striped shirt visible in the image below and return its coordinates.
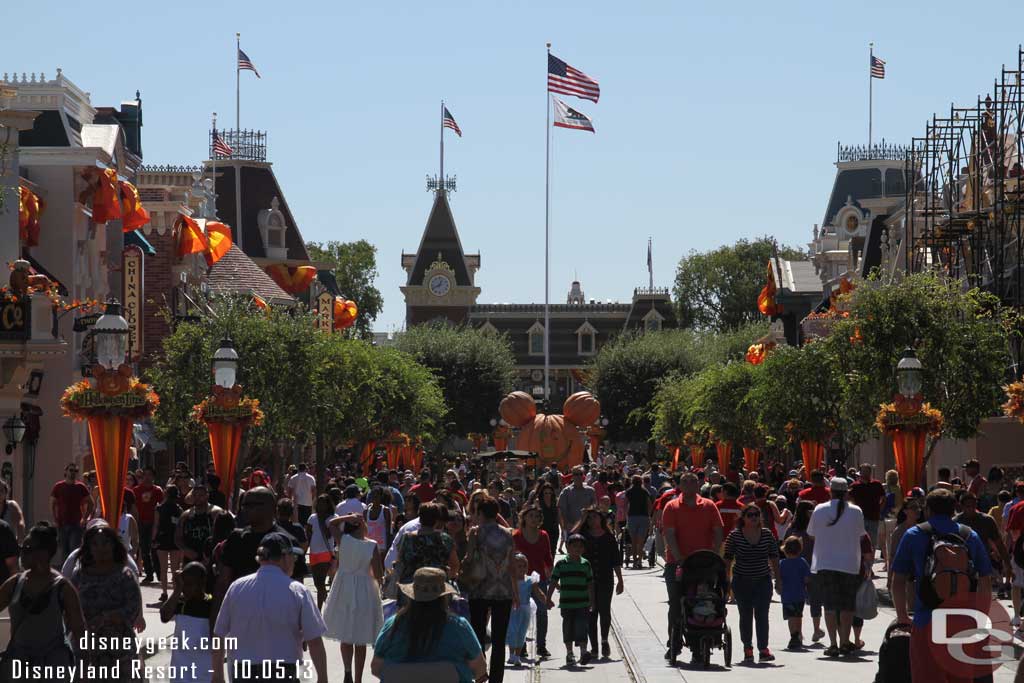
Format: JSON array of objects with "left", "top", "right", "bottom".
[{"left": 548, "top": 533, "right": 594, "bottom": 667}]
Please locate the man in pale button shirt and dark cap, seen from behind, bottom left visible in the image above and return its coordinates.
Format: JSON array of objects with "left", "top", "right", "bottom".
[{"left": 213, "top": 531, "right": 328, "bottom": 683}]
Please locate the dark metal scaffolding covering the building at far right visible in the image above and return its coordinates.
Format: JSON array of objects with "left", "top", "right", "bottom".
[{"left": 904, "top": 47, "right": 1024, "bottom": 308}]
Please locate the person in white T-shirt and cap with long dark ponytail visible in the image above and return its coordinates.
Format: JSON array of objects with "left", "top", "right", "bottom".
[{"left": 807, "top": 477, "right": 864, "bottom": 656}]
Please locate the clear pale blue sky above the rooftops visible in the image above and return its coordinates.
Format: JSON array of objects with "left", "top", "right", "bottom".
[{"left": 8, "top": 0, "right": 1024, "bottom": 330}]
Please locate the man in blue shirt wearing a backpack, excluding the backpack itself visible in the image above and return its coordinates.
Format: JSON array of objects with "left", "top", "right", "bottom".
[{"left": 892, "top": 488, "right": 992, "bottom": 683}]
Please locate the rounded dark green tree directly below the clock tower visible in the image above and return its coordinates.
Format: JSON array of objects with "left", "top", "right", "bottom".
[{"left": 395, "top": 324, "right": 515, "bottom": 434}]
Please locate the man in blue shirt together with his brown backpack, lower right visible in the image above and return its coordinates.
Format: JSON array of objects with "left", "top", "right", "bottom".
[{"left": 892, "top": 488, "right": 992, "bottom": 683}]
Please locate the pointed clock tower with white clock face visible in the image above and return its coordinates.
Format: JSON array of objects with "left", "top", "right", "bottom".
[{"left": 401, "top": 185, "right": 480, "bottom": 326}]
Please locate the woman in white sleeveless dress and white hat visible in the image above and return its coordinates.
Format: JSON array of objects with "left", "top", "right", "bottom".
[{"left": 324, "top": 514, "right": 384, "bottom": 683}]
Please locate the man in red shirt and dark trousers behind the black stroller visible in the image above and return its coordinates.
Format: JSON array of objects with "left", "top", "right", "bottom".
[{"left": 662, "top": 472, "right": 723, "bottom": 658}]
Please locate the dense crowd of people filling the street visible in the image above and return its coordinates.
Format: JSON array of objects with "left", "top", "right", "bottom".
[{"left": 0, "top": 453, "right": 1007, "bottom": 683}]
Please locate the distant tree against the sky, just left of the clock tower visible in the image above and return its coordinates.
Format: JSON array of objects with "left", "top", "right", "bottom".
[{"left": 306, "top": 240, "right": 384, "bottom": 339}]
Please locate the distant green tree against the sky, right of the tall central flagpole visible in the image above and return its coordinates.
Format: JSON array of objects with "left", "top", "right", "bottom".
[{"left": 675, "top": 237, "right": 805, "bottom": 331}]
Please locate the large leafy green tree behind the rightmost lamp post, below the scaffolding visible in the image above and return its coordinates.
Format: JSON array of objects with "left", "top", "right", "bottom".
[{"left": 827, "top": 273, "right": 1016, "bottom": 446}]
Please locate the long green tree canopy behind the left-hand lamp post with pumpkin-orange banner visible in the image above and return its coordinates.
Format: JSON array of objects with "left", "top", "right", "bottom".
[{"left": 148, "top": 298, "right": 446, "bottom": 449}]
